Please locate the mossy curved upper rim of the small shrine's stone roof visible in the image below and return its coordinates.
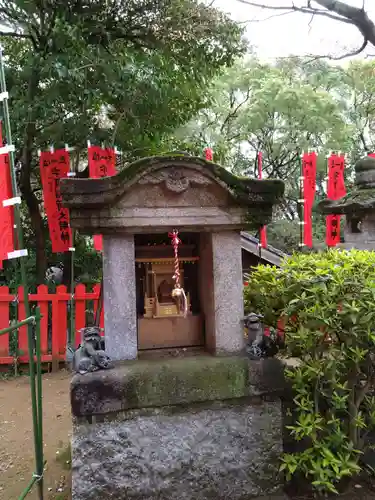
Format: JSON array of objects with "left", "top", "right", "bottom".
[{"left": 60, "top": 154, "right": 284, "bottom": 227}]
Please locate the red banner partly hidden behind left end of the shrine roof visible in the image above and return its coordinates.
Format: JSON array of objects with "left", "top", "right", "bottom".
[{"left": 87, "top": 146, "right": 117, "bottom": 252}]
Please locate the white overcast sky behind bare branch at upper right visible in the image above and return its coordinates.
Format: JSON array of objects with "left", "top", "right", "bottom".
[{"left": 214, "top": 0, "right": 375, "bottom": 59}]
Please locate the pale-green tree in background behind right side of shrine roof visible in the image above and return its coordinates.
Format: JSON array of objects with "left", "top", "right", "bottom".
[{"left": 175, "top": 57, "right": 352, "bottom": 251}]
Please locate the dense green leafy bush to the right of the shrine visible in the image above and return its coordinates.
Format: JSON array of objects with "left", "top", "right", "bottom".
[{"left": 245, "top": 250, "right": 375, "bottom": 492}]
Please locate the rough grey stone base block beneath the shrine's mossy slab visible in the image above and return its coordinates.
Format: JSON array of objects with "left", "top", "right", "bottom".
[{"left": 72, "top": 403, "right": 281, "bottom": 500}]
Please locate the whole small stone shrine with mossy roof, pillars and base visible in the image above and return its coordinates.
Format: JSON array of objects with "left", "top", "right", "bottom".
[{"left": 61, "top": 155, "right": 284, "bottom": 500}]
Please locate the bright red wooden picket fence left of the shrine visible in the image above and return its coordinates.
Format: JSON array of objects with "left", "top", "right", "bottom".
[{"left": 0, "top": 284, "right": 104, "bottom": 365}]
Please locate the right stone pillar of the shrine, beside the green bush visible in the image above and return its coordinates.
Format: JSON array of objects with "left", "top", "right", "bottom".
[{"left": 212, "top": 231, "right": 245, "bottom": 354}]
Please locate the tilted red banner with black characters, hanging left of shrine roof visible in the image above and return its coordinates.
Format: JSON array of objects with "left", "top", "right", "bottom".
[{"left": 40, "top": 149, "right": 72, "bottom": 253}]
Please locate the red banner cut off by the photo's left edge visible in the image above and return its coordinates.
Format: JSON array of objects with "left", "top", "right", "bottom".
[{"left": 0, "top": 153, "right": 14, "bottom": 269}]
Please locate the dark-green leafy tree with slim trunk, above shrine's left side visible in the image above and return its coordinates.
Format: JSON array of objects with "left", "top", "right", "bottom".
[{"left": 0, "top": 0, "right": 244, "bottom": 282}]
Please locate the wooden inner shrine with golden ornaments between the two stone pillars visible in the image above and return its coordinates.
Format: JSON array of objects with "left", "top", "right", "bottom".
[{"left": 135, "top": 233, "right": 204, "bottom": 350}]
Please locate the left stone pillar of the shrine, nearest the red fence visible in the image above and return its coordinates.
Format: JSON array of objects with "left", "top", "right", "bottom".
[{"left": 103, "top": 235, "right": 138, "bottom": 361}]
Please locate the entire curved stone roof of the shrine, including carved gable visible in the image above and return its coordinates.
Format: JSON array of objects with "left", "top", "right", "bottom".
[{"left": 60, "top": 156, "right": 284, "bottom": 234}]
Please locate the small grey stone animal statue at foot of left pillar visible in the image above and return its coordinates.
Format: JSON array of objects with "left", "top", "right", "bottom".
[{"left": 73, "top": 326, "right": 112, "bottom": 374}]
